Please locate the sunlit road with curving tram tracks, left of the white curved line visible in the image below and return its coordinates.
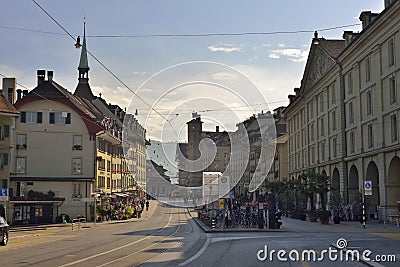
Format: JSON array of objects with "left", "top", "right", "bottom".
[{"left": 0, "top": 204, "right": 200, "bottom": 267}]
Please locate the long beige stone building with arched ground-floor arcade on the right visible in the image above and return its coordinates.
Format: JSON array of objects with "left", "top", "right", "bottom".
[{"left": 286, "top": 1, "right": 400, "bottom": 220}]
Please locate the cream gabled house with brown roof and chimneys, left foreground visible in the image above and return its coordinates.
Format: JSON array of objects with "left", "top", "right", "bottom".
[{"left": 10, "top": 70, "right": 102, "bottom": 224}]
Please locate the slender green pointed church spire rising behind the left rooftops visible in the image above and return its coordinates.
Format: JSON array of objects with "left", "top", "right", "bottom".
[{"left": 74, "top": 19, "right": 95, "bottom": 100}]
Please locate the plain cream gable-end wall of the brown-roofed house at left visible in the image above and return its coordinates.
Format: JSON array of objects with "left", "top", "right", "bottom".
[{"left": 10, "top": 100, "right": 95, "bottom": 219}]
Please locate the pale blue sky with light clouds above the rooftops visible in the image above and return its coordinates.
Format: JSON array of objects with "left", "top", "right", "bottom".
[{"left": 0, "top": 0, "right": 384, "bottom": 142}]
